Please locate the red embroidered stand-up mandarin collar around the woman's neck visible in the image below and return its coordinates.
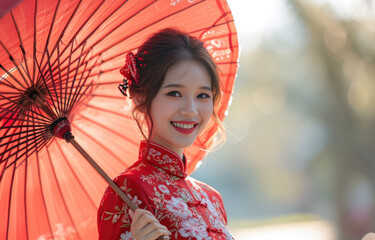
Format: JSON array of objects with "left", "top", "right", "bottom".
[{"left": 139, "top": 141, "right": 187, "bottom": 178}]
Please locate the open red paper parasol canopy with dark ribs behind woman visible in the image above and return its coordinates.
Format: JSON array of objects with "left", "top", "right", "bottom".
[{"left": 0, "top": 0, "right": 238, "bottom": 239}]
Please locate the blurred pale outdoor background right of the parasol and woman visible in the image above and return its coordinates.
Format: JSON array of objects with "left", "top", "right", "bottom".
[{"left": 192, "top": 0, "right": 375, "bottom": 240}]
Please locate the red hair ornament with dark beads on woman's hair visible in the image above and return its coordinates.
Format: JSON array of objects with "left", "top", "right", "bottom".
[{"left": 119, "top": 52, "right": 139, "bottom": 96}]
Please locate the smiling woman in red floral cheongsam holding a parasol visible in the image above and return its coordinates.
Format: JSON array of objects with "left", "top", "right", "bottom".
[{"left": 98, "top": 29, "right": 233, "bottom": 240}]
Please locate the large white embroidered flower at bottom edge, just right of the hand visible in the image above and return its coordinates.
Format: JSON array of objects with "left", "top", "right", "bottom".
[{"left": 178, "top": 218, "right": 208, "bottom": 240}]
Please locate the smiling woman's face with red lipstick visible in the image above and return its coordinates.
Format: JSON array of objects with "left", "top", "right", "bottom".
[{"left": 151, "top": 60, "right": 213, "bottom": 157}]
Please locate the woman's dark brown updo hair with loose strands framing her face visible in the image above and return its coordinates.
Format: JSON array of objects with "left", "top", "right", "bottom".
[{"left": 129, "top": 28, "right": 223, "bottom": 149}]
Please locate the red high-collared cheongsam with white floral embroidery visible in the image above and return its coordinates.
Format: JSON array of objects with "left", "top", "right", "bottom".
[{"left": 98, "top": 141, "right": 234, "bottom": 240}]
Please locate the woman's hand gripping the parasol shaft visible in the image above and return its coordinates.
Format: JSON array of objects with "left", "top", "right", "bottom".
[{"left": 130, "top": 209, "right": 171, "bottom": 240}]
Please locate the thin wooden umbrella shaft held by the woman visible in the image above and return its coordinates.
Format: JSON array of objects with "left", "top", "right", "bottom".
[{"left": 68, "top": 136, "right": 169, "bottom": 240}]
